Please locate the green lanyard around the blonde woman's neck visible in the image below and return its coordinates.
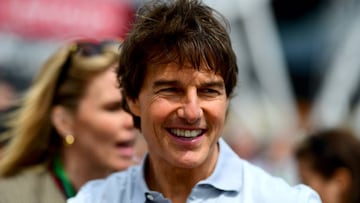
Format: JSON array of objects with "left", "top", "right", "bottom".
[{"left": 54, "top": 156, "right": 76, "bottom": 198}]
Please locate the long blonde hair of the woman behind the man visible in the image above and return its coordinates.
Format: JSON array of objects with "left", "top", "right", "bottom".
[{"left": 0, "top": 42, "right": 119, "bottom": 176}]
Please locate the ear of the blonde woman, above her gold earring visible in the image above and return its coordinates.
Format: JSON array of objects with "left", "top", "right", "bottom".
[{"left": 51, "top": 105, "right": 73, "bottom": 137}]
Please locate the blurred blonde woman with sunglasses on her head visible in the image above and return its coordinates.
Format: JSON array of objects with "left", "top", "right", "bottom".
[{"left": 0, "top": 40, "right": 137, "bottom": 203}]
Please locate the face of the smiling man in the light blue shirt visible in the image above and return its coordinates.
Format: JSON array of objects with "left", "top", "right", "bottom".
[{"left": 129, "top": 63, "right": 228, "bottom": 168}]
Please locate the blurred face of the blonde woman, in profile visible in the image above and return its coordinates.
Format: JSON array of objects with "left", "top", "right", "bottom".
[{"left": 72, "top": 68, "right": 137, "bottom": 170}]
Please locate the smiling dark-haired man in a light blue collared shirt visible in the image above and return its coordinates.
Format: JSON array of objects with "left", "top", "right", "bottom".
[{"left": 69, "top": 0, "right": 320, "bottom": 203}]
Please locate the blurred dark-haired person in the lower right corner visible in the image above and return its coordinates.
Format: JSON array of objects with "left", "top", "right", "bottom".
[{"left": 295, "top": 128, "right": 360, "bottom": 203}]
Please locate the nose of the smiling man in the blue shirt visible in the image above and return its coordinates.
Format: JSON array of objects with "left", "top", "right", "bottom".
[{"left": 177, "top": 90, "right": 202, "bottom": 124}]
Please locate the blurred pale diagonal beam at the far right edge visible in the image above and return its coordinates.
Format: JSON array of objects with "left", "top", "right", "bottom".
[{"left": 310, "top": 0, "right": 360, "bottom": 138}]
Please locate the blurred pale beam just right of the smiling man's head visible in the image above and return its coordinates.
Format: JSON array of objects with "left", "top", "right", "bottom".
[{"left": 204, "top": 0, "right": 298, "bottom": 139}]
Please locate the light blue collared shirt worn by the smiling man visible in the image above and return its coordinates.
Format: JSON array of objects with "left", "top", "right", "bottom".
[{"left": 68, "top": 139, "right": 321, "bottom": 203}]
